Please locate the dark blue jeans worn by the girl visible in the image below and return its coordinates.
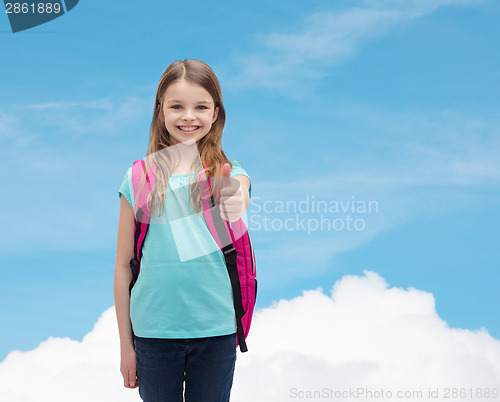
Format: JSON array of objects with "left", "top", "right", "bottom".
[{"left": 134, "top": 334, "right": 236, "bottom": 402}]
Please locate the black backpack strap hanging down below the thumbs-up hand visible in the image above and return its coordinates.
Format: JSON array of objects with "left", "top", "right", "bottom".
[{"left": 210, "top": 196, "right": 248, "bottom": 352}]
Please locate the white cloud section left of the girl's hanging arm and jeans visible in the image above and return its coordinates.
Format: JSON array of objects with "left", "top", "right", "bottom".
[{"left": 0, "top": 308, "right": 140, "bottom": 402}]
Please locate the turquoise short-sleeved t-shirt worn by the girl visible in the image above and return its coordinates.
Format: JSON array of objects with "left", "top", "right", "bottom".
[{"left": 118, "top": 161, "right": 251, "bottom": 338}]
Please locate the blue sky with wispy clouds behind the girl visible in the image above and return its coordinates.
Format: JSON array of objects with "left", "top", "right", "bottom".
[{"left": 0, "top": 0, "right": 500, "bottom": 359}]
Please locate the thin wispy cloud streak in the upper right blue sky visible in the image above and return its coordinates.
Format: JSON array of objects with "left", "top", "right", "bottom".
[{"left": 220, "top": 0, "right": 485, "bottom": 99}]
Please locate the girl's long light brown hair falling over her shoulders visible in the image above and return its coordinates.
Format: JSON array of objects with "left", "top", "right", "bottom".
[{"left": 139, "top": 59, "right": 232, "bottom": 215}]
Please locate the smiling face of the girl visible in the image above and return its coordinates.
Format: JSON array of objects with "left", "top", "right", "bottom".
[{"left": 163, "top": 79, "right": 219, "bottom": 144}]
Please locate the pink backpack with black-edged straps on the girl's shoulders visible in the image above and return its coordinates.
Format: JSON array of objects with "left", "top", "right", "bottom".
[{"left": 129, "top": 159, "right": 257, "bottom": 352}]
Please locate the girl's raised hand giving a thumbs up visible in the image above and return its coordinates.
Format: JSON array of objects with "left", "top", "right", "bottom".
[{"left": 220, "top": 163, "right": 250, "bottom": 222}]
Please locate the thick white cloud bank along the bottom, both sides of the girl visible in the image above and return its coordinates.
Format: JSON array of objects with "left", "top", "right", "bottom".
[{"left": 0, "top": 271, "right": 500, "bottom": 402}]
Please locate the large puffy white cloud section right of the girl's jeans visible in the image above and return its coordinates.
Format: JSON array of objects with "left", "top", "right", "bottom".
[{"left": 235, "top": 272, "right": 500, "bottom": 402}]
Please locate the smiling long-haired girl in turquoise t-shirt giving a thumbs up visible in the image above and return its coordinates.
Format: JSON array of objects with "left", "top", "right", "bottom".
[{"left": 114, "top": 60, "right": 251, "bottom": 402}]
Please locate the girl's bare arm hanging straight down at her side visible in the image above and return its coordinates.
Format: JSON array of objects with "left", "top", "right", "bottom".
[{"left": 114, "top": 195, "right": 137, "bottom": 388}]
